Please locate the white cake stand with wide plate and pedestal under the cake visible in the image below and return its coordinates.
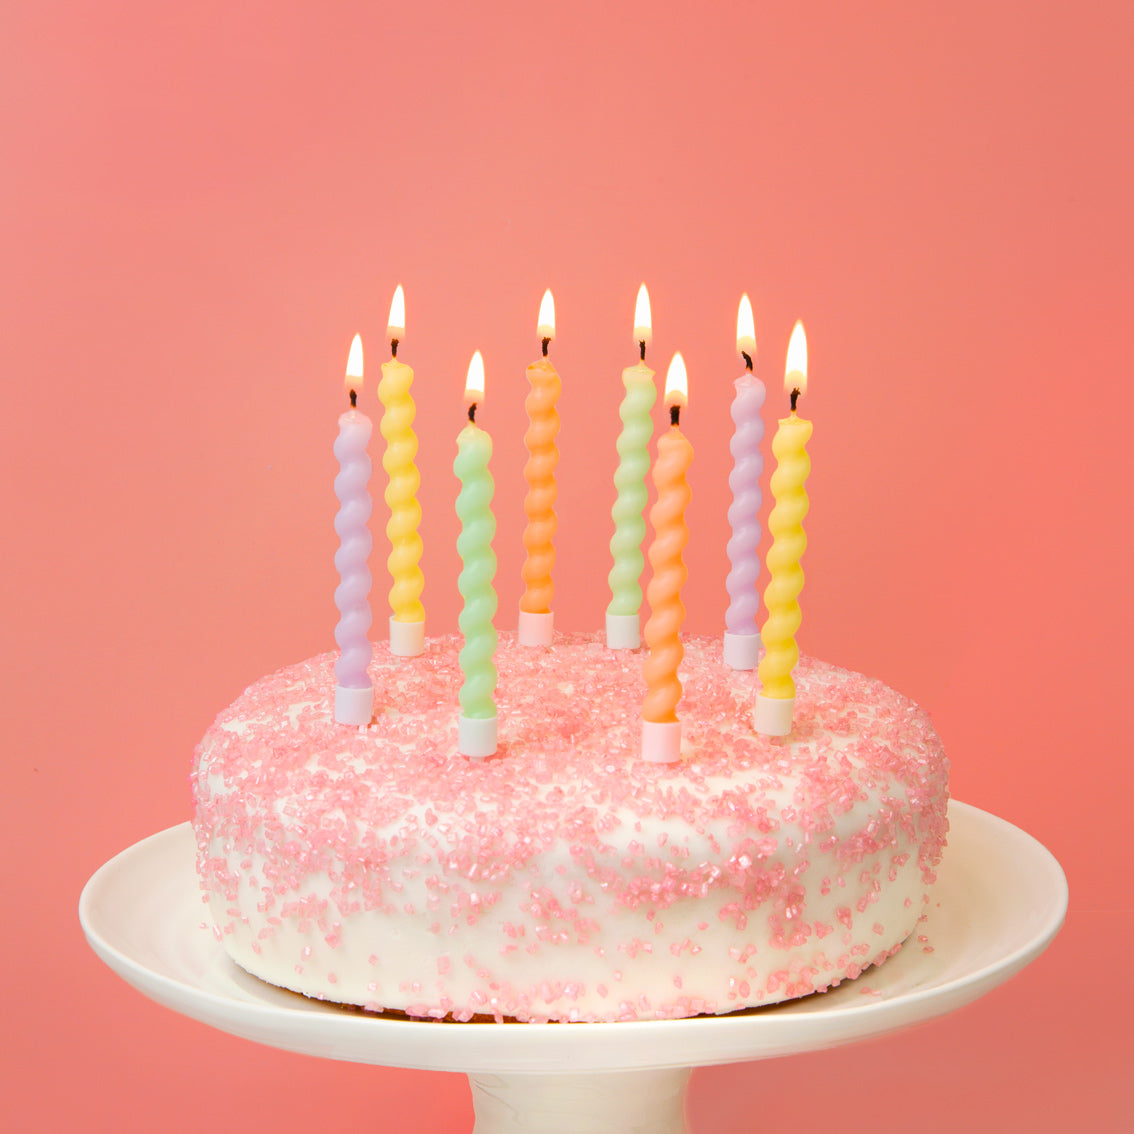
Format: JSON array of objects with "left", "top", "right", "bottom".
[{"left": 79, "top": 802, "right": 1067, "bottom": 1134}]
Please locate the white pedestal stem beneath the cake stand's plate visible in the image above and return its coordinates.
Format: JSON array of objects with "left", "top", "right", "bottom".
[{"left": 468, "top": 1067, "right": 693, "bottom": 1134}]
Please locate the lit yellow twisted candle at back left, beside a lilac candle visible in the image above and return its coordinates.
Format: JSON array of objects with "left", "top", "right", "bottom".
[{"left": 378, "top": 284, "right": 425, "bottom": 658}]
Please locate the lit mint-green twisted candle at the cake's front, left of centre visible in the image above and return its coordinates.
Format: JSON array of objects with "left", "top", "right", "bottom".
[{"left": 452, "top": 350, "right": 497, "bottom": 758}]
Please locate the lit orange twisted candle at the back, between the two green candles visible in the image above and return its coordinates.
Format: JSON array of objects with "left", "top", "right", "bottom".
[{"left": 519, "top": 291, "right": 562, "bottom": 645}]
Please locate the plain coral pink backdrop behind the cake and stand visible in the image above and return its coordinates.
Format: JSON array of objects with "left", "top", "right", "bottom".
[{"left": 0, "top": 0, "right": 1134, "bottom": 1134}]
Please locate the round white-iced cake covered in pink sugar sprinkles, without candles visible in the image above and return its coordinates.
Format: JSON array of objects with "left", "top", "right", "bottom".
[{"left": 193, "top": 634, "right": 948, "bottom": 1021}]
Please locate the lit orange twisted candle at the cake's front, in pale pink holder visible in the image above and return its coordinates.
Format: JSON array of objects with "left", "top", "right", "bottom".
[{"left": 642, "top": 354, "right": 693, "bottom": 763}]
